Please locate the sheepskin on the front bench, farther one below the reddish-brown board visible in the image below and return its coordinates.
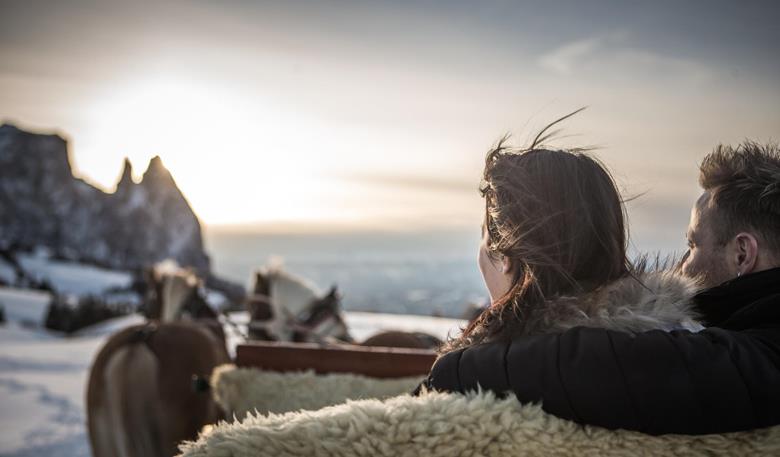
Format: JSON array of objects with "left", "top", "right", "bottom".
[{"left": 210, "top": 365, "right": 425, "bottom": 418}]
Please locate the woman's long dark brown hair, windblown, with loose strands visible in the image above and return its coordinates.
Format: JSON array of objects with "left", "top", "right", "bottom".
[{"left": 444, "top": 110, "right": 629, "bottom": 351}]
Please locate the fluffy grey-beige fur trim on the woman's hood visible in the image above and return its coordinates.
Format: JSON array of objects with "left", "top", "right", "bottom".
[{"left": 444, "top": 269, "right": 704, "bottom": 352}]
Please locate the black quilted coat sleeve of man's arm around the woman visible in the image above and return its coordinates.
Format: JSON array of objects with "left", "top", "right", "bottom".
[{"left": 426, "top": 328, "right": 780, "bottom": 434}]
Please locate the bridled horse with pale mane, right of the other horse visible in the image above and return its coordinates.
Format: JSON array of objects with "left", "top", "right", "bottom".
[{"left": 247, "top": 267, "right": 442, "bottom": 349}]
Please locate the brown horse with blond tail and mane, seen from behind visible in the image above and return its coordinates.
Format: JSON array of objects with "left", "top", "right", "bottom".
[{"left": 86, "top": 262, "right": 230, "bottom": 457}]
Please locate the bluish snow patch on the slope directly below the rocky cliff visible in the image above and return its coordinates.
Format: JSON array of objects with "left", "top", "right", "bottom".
[{"left": 18, "top": 253, "right": 133, "bottom": 296}]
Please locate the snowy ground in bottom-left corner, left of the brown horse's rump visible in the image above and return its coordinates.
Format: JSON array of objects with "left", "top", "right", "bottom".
[{"left": 0, "top": 323, "right": 103, "bottom": 457}]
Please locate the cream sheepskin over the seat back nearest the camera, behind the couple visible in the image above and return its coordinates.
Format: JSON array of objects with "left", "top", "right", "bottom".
[{"left": 181, "top": 386, "right": 780, "bottom": 457}]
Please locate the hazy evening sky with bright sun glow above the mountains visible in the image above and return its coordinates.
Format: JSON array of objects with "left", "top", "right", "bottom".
[{"left": 0, "top": 0, "right": 780, "bottom": 250}]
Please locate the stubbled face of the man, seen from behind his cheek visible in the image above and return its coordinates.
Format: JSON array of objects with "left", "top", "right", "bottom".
[{"left": 682, "top": 192, "right": 735, "bottom": 288}]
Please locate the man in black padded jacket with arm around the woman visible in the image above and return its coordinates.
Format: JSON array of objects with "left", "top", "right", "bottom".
[{"left": 424, "top": 142, "right": 780, "bottom": 435}]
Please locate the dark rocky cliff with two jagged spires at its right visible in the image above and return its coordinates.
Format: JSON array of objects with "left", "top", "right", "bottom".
[{"left": 0, "top": 125, "right": 209, "bottom": 274}]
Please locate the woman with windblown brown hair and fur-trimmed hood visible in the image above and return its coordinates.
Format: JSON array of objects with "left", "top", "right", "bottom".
[{"left": 443, "top": 111, "right": 701, "bottom": 352}]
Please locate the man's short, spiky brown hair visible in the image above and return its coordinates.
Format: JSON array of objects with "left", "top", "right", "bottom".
[{"left": 699, "top": 141, "right": 780, "bottom": 255}]
